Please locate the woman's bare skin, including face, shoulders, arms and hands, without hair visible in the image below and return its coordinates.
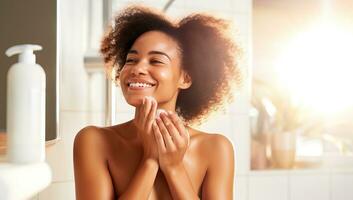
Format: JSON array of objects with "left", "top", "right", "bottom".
[{"left": 74, "top": 31, "right": 234, "bottom": 200}]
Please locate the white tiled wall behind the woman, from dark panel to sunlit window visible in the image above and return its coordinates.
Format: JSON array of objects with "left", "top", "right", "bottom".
[{"left": 33, "top": 0, "right": 251, "bottom": 200}]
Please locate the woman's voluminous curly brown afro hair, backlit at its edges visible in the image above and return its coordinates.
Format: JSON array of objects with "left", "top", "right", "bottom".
[{"left": 100, "top": 6, "right": 241, "bottom": 123}]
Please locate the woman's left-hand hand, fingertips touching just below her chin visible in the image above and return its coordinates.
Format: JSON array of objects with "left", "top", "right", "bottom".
[{"left": 134, "top": 96, "right": 158, "bottom": 161}]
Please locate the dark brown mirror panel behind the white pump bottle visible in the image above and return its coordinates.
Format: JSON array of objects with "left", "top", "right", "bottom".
[{"left": 0, "top": 0, "right": 59, "bottom": 144}]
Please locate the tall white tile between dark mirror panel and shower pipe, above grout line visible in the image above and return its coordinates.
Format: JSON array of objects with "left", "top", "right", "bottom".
[{"left": 59, "top": 0, "right": 88, "bottom": 111}]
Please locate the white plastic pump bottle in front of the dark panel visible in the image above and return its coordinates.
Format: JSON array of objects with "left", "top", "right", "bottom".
[{"left": 6, "top": 44, "right": 46, "bottom": 163}]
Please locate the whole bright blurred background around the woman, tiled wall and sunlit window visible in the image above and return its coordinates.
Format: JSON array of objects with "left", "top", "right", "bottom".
[{"left": 2, "top": 0, "right": 353, "bottom": 200}]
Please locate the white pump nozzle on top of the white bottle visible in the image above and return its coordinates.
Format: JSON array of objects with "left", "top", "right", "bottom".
[{"left": 5, "top": 44, "right": 42, "bottom": 64}]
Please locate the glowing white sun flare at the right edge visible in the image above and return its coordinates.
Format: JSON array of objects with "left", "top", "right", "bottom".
[{"left": 276, "top": 21, "right": 353, "bottom": 113}]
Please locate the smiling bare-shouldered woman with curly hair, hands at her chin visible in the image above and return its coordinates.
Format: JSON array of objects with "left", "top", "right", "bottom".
[{"left": 74, "top": 6, "right": 240, "bottom": 200}]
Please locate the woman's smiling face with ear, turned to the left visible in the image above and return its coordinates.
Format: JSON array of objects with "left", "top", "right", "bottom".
[{"left": 120, "top": 31, "right": 190, "bottom": 109}]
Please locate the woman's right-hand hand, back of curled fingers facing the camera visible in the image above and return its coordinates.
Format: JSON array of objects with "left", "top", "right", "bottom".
[{"left": 152, "top": 112, "right": 190, "bottom": 171}]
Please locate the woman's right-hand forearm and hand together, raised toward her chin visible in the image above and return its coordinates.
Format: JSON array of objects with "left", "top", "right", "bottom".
[{"left": 153, "top": 113, "right": 199, "bottom": 200}]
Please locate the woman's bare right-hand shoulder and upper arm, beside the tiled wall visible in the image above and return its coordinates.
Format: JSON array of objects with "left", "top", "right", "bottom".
[{"left": 202, "top": 134, "right": 234, "bottom": 199}]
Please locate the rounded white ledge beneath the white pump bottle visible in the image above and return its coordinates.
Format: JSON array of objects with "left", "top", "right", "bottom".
[{"left": 0, "top": 162, "right": 52, "bottom": 200}]
